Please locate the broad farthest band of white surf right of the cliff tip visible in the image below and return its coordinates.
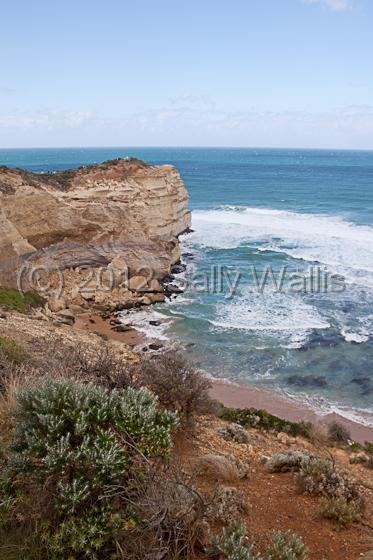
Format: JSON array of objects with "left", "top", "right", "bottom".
[{"left": 191, "top": 207, "right": 373, "bottom": 289}]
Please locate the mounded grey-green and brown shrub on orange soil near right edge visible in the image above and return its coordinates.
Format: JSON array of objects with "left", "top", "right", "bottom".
[{"left": 295, "top": 457, "right": 359, "bottom": 500}]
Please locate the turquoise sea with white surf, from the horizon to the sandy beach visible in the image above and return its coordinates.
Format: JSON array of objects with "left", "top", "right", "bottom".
[{"left": 0, "top": 148, "right": 373, "bottom": 421}]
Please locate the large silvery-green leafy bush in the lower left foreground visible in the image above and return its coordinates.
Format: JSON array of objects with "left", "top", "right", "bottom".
[{"left": 1, "top": 380, "right": 177, "bottom": 560}]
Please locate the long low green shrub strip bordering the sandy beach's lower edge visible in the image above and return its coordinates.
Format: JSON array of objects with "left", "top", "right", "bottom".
[{"left": 219, "top": 407, "right": 312, "bottom": 438}]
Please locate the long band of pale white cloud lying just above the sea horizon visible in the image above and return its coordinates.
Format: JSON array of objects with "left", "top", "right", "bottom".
[{"left": 0, "top": 100, "right": 373, "bottom": 149}]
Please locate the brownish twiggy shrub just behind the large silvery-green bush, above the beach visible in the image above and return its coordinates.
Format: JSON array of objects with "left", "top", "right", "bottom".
[{"left": 137, "top": 350, "right": 211, "bottom": 423}]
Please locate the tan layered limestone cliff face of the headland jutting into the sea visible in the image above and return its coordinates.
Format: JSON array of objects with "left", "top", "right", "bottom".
[{"left": 0, "top": 159, "right": 190, "bottom": 310}]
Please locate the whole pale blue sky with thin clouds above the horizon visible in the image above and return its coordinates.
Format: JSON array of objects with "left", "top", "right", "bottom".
[{"left": 0, "top": 0, "right": 373, "bottom": 149}]
